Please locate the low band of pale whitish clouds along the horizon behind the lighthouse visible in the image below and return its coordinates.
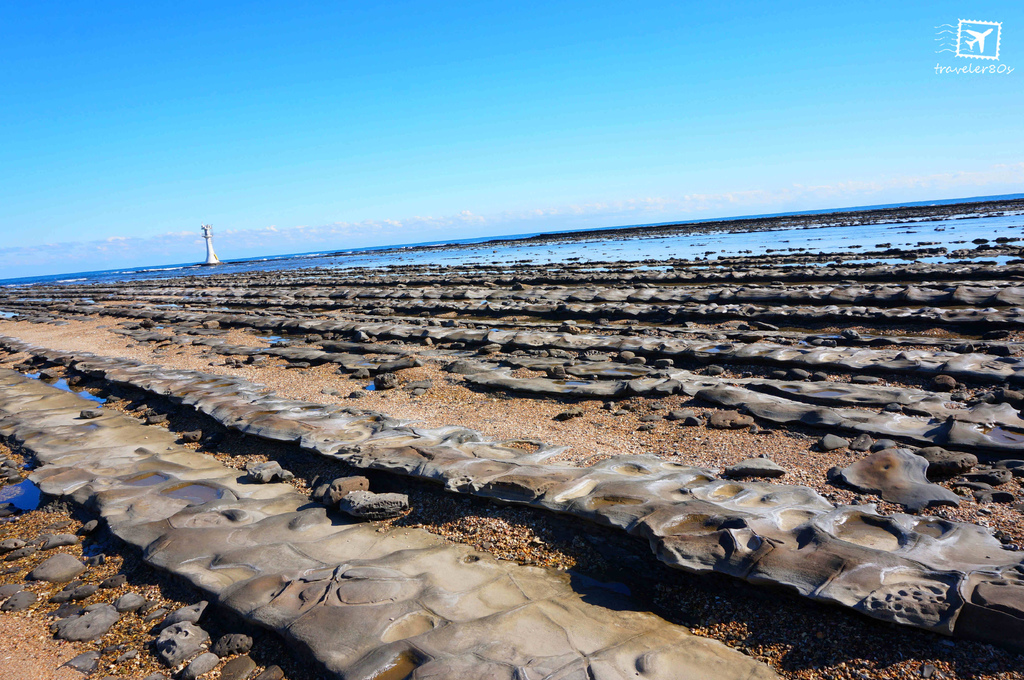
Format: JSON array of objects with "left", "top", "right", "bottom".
[{"left": 0, "top": 163, "right": 1024, "bottom": 277}]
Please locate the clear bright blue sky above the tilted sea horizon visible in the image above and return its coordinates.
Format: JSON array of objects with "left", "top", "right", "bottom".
[{"left": 0, "top": 0, "right": 1024, "bottom": 279}]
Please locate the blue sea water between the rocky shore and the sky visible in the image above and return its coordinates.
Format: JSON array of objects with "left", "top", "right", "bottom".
[{"left": 0, "top": 194, "right": 1024, "bottom": 287}]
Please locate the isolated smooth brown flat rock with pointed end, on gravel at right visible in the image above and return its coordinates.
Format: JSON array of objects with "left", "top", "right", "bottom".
[{"left": 840, "top": 449, "right": 959, "bottom": 512}]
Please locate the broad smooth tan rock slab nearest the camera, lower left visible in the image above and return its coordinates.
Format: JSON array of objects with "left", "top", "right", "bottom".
[{"left": 0, "top": 371, "right": 775, "bottom": 680}]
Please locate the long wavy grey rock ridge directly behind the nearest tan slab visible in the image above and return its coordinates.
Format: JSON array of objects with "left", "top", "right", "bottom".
[{"left": 6, "top": 346, "right": 1024, "bottom": 648}]
